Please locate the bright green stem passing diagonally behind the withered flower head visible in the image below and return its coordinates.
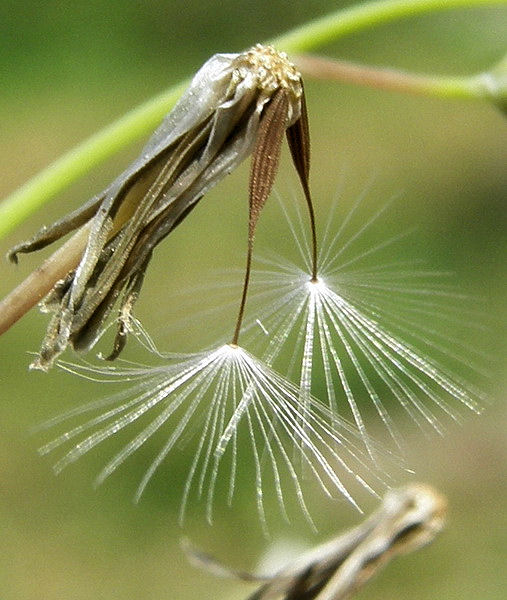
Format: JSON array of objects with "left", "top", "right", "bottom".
[{"left": 0, "top": 0, "right": 507, "bottom": 238}]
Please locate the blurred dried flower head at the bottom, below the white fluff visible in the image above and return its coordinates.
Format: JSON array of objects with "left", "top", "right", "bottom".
[{"left": 183, "top": 484, "right": 446, "bottom": 600}]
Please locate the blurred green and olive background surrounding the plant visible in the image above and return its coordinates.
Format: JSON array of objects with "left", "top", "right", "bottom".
[{"left": 0, "top": 0, "right": 507, "bottom": 600}]
